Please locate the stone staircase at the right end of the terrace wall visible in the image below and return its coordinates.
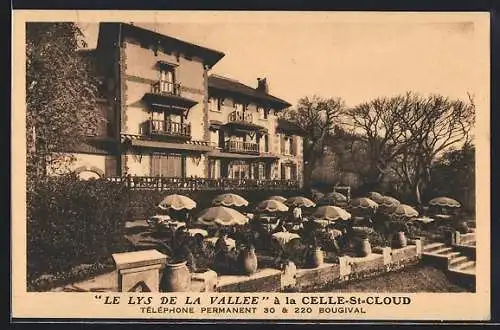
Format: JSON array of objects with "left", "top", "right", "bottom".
[{"left": 422, "top": 242, "right": 476, "bottom": 289}]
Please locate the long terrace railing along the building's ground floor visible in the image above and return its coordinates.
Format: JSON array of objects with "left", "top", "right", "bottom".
[{"left": 105, "top": 176, "right": 300, "bottom": 191}]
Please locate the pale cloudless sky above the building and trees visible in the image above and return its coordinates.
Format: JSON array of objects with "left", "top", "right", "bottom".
[{"left": 76, "top": 14, "right": 488, "bottom": 106}]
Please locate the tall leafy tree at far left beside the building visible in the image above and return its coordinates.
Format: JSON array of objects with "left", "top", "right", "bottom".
[{"left": 26, "top": 22, "right": 103, "bottom": 183}]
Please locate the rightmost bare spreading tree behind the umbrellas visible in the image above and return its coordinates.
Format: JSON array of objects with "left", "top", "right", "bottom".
[{"left": 394, "top": 95, "right": 475, "bottom": 205}]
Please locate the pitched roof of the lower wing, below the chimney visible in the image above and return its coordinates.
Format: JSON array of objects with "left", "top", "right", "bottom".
[{"left": 208, "top": 74, "right": 291, "bottom": 110}]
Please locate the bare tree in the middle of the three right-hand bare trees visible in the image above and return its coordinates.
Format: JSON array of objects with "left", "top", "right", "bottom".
[{"left": 346, "top": 93, "right": 412, "bottom": 190}]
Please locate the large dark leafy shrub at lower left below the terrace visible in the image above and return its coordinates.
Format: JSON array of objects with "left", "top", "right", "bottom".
[{"left": 27, "top": 174, "right": 129, "bottom": 280}]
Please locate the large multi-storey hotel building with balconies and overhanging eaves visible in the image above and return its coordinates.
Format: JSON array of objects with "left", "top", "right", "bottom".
[{"left": 65, "top": 23, "right": 303, "bottom": 186}]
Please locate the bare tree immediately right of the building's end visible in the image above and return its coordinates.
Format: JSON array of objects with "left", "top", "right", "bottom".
[{"left": 285, "top": 95, "right": 345, "bottom": 191}]
